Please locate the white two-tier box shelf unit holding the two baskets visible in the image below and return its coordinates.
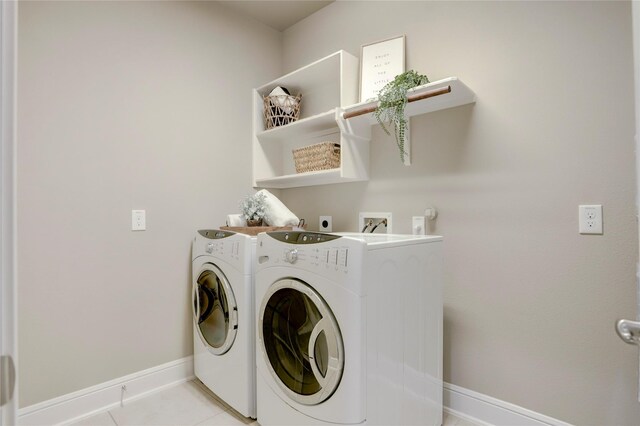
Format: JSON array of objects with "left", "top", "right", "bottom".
[{"left": 253, "top": 50, "right": 371, "bottom": 188}]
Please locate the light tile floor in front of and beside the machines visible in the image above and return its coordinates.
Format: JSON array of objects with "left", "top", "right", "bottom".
[{"left": 73, "top": 380, "right": 476, "bottom": 426}]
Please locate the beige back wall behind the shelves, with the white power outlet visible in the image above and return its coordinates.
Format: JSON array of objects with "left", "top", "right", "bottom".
[{"left": 282, "top": 2, "right": 640, "bottom": 425}]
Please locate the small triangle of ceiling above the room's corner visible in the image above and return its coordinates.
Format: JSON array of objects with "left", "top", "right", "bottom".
[{"left": 219, "top": 0, "right": 334, "bottom": 31}]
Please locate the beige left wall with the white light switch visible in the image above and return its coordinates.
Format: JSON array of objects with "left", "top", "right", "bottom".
[{"left": 18, "top": 2, "right": 282, "bottom": 407}]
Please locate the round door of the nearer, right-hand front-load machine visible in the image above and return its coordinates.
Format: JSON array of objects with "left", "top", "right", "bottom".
[{"left": 259, "top": 279, "right": 344, "bottom": 405}]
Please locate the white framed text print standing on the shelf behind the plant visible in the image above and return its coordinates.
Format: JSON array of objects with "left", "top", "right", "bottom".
[{"left": 360, "top": 35, "right": 405, "bottom": 102}]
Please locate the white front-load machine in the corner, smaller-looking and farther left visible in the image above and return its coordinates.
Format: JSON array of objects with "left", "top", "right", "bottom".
[{"left": 192, "top": 229, "right": 256, "bottom": 418}]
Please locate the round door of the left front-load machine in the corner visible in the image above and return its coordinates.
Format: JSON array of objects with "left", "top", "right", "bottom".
[{"left": 193, "top": 264, "right": 238, "bottom": 355}]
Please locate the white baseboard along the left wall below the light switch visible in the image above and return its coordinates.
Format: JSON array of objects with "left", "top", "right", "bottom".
[{"left": 18, "top": 356, "right": 194, "bottom": 426}]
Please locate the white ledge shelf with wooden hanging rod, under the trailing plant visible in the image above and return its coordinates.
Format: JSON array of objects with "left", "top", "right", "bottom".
[{"left": 343, "top": 77, "right": 476, "bottom": 124}]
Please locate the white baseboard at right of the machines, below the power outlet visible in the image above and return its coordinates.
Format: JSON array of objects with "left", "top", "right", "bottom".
[{"left": 443, "top": 383, "right": 571, "bottom": 426}]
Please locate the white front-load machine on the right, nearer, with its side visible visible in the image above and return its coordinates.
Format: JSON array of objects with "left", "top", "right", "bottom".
[{"left": 255, "top": 231, "right": 442, "bottom": 426}]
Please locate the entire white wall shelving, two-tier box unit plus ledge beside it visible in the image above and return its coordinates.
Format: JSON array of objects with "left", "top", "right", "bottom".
[{"left": 253, "top": 50, "right": 476, "bottom": 188}]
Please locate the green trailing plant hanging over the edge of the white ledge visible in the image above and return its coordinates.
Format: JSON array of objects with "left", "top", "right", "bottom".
[{"left": 374, "top": 70, "right": 429, "bottom": 162}]
